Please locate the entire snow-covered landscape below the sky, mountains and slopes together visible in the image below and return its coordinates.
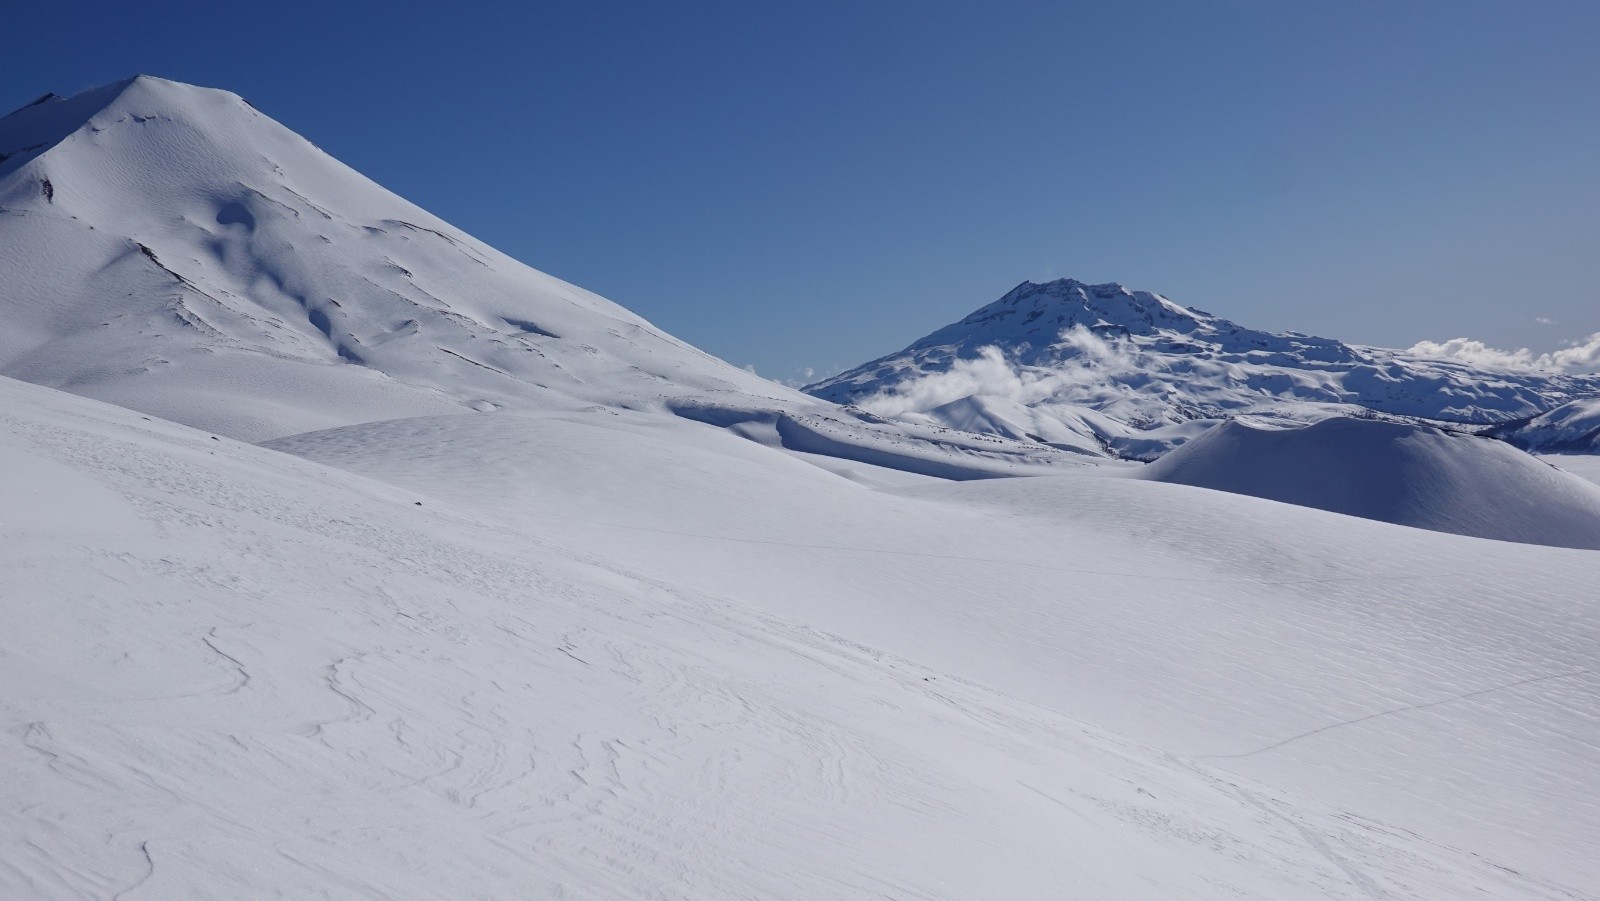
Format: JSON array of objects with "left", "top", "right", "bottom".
[{"left": 0, "top": 77, "right": 1600, "bottom": 899}]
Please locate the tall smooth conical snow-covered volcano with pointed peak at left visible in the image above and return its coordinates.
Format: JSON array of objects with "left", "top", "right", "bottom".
[{"left": 0, "top": 77, "right": 814, "bottom": 440}]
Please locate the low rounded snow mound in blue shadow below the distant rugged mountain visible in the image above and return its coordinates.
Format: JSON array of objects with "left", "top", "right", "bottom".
[{"left": 1139, "top": 418, "right": 1600, "bottom": 549}]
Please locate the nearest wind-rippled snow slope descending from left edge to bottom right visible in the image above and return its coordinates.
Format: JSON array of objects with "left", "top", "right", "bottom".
[{"left": 0, "top": 369, "right": 1582, "bottom": 898}]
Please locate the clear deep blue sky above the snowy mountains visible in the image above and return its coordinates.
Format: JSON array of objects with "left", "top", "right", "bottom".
[{"left": 0, "top": 0, "right": 1600, "bottom": 378}]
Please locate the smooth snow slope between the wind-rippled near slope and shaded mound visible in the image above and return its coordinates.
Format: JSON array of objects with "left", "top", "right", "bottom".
[{"left": 272, "top": 411, "right": 1600, "bottom": 896}]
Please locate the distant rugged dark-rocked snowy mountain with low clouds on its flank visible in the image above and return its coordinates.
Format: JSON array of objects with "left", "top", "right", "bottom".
[{"left": 805, "top": 278, "right": 1600, "bottom": 459}]
